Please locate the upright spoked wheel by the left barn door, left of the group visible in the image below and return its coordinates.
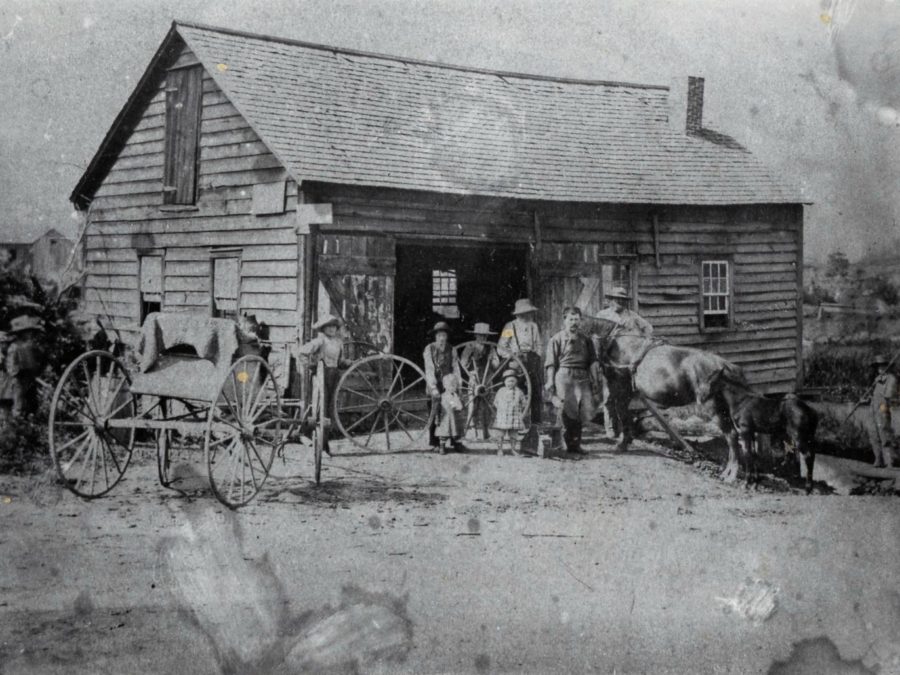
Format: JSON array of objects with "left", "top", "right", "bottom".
[{"left": 334, "top": 354, "right": 434, "bottom": 452}]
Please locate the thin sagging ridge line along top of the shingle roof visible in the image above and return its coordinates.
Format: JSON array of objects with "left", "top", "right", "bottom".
[{"left": 172, "top": 19, "right": 669, "bottom": 91}]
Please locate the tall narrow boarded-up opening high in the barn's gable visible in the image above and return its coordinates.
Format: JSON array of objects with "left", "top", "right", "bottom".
[{"left": 163, "top": 66, "right": 203, "bottom": 204}]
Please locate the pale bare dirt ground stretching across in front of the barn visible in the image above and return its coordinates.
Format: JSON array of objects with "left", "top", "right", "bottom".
[{"left": 0, "top": 430, "right": 900, "bottom": 674}]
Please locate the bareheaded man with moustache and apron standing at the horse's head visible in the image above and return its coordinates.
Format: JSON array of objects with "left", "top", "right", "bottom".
[{"left": 544, "top": 307, "right": 600, "bottom": 452}]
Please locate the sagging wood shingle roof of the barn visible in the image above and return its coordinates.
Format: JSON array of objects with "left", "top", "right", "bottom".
[{"left": 72, "top": 23, "right": 804, "bottom": 205}]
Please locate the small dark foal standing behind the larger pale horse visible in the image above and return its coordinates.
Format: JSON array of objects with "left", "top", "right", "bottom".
[{"left": 713, "top": 371, "right": 819, "bottom": 494}]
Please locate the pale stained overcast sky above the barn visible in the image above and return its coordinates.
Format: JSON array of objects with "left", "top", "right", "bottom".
[{"left": 0, "top": 0, "right": 900, "bottom": 260}]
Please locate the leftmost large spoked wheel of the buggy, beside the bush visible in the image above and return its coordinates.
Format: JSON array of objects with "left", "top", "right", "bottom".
[{"left": 49, "top": 351, "right": 137, "bottom": 499}]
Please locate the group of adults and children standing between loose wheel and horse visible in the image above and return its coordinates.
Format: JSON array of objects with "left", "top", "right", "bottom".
[{"left": 422, "top": 287, "right": 653, "bottom": 455}]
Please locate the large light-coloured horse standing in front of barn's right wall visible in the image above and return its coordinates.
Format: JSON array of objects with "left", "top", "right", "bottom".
[{"left": 585, "top": 317, "right": 744, "bottom": 483}]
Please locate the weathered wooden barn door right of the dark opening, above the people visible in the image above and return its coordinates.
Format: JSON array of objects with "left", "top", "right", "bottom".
[{"left": 537, "top": 243, "right": 604, "bottom": 340}]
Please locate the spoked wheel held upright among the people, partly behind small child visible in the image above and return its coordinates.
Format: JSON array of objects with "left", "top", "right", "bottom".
[{"left": 453, "top": 340, "right": 531, "bottom": 440}]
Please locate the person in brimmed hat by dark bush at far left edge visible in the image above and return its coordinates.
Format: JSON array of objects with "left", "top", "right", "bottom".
[{"left": 4, "top": 315, "right": 44, "bottom": 420}]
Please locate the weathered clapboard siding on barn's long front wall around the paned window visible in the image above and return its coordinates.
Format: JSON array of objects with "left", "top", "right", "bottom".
[{"left": 305, "top": 185, "right": 802, "bottom": 390}]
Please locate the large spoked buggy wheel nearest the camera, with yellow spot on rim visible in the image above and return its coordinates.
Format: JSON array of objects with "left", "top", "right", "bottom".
[{"left": 205, "top": 356, "right": 284, "bottom": 509}]
